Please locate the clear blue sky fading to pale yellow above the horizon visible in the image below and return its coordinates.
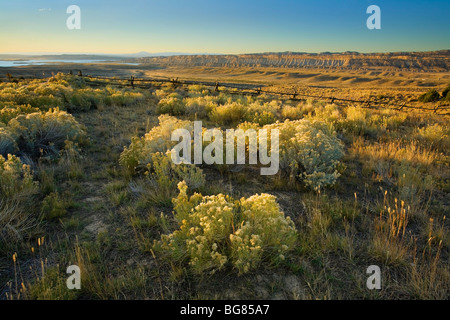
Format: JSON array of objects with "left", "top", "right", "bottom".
[{"left": 0, "top": 0, "right": 450, "bottom": 54}]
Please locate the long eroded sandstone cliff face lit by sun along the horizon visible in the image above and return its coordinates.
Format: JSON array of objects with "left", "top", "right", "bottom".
[{"left": 137, "top": 50, "right": 450, "bottom": 72}]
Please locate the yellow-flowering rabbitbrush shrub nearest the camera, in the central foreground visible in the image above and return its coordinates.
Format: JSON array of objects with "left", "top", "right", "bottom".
[{"left": 155, "top": 182, "right": 297, "bottom": 274}]
